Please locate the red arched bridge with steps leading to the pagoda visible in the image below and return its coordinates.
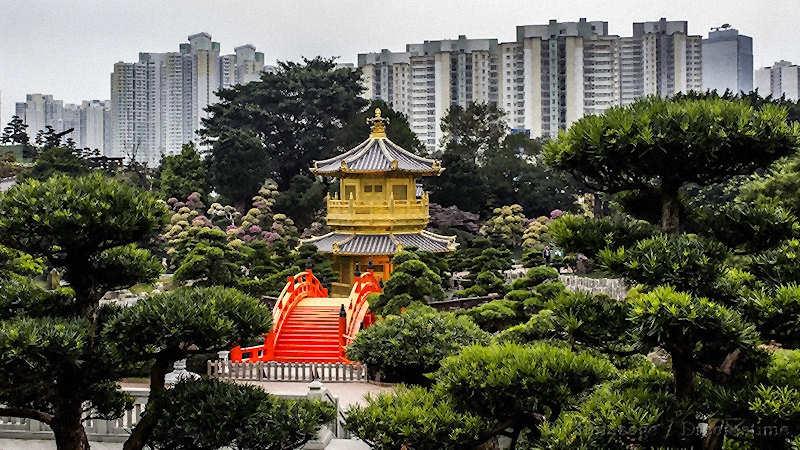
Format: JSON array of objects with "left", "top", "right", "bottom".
[{"left": 230, "top": 269, "right": 381, "bottom": 363}]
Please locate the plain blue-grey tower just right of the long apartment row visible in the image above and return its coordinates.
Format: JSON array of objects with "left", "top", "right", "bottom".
[{"left": 703, "top": 24, "right": 753, "bottom": 93}]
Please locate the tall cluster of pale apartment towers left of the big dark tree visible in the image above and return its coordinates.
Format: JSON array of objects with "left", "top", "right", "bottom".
[{"left": 109, "top": 33, "right": 264, "bottom": 166}]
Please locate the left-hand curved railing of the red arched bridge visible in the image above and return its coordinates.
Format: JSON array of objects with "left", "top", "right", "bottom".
[{"left": 230, "top": 269, "right": 328, "bottom": 362}]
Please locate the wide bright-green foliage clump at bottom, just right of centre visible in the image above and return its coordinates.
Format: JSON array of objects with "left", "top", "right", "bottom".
[{"left": 435, "top": 343, "right": 616, "bottom": 440}]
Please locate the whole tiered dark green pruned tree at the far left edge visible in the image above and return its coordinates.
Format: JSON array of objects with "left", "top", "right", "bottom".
[{"left": 0, "top": 174, "right": 177, "bottom": 448}]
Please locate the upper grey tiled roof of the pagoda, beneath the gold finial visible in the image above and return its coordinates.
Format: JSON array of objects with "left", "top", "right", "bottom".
[{"left": 312, "top": 137, "right": 442, "bottom": 175}]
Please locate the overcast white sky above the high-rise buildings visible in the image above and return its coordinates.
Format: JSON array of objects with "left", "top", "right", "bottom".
[{"left": 0, "top": 0, "right": 800, "bottom": 123}]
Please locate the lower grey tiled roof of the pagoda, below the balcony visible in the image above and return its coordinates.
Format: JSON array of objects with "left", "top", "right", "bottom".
[{"left": 303, "top": 231, "right": 456, "bottom": 255}]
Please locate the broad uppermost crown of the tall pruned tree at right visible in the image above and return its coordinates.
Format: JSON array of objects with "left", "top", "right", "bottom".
[{"left": 545, "top": 97, "right": 800, "bottom": 232}]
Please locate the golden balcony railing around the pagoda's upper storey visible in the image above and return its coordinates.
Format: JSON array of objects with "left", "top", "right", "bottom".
[{"left": 328, "top": 196, "right": 429, "bottom": 227}]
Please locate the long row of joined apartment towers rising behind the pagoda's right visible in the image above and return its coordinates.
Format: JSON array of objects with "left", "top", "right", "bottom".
[{"left": 358, "top": 18, "right": 703, "bottom": 145}]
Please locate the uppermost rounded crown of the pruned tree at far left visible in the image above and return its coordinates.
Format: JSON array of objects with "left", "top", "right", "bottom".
[{"left": 0, "top": 174, "right": 166, "bottom": 306}]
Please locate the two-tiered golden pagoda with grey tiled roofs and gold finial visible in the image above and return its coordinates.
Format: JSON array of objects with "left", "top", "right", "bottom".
[{"left": 303, "top": 109, "right": 456, "bottom": 290}]
